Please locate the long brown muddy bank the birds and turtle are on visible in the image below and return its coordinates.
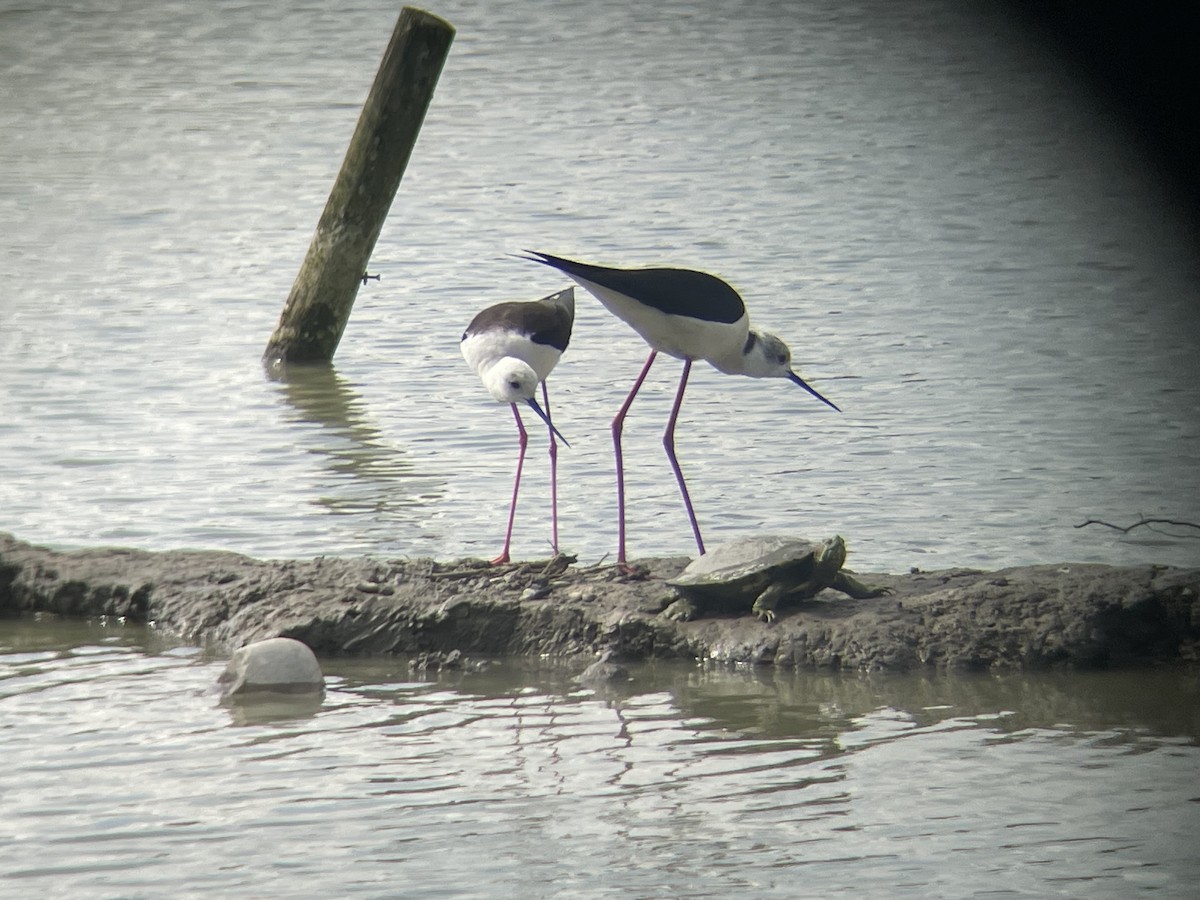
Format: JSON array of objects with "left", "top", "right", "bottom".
[{"left": 0, "top": 533, "right": 1200, "bottom": 671}]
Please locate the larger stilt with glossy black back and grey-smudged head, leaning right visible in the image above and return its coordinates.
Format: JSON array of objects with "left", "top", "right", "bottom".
[{"left": 523, "top": 251, "right": 841, "bottom": 569}]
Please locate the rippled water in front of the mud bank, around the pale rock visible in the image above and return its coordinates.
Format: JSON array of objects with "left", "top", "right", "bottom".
[{"left": 0, "top": 620, "right": 1200, "bottom": 898}]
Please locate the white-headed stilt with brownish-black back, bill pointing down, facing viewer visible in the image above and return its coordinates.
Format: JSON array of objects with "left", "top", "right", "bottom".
[{"left": 460, "top": 288, "right": 575, "bottom": 565}]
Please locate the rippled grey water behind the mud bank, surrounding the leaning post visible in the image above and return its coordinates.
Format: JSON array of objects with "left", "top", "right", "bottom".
[{"left": 0, "top": 0, "right": 1200, "bottom": 570}]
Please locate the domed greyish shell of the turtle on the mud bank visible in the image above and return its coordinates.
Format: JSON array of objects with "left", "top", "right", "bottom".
[{"left": 667, "top": 535, "right": 822, "bottom": 602}]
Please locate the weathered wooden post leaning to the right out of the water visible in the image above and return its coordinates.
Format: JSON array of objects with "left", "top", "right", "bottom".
[{"left": 263, "top": 6, "right": 455, "bottom": 368}]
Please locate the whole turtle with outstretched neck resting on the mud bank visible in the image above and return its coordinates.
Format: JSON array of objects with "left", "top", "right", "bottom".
[{"left": 662, "top": 535, "right": 888, "bottom": 622}]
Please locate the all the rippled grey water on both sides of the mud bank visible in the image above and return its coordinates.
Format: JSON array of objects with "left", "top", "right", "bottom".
[{"left": 0, "top": 0, "right": 1200, "bottom": 896}]
